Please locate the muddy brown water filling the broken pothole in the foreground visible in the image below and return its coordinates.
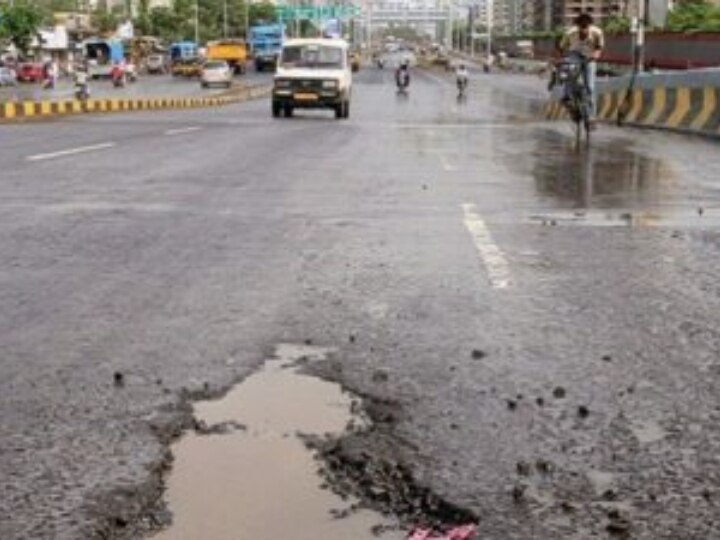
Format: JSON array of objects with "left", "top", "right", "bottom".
[{"left": 153, "top": 345, "right": 405, "bottom": 540}]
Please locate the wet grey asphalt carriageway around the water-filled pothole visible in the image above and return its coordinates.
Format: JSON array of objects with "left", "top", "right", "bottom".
[{"left": 0, "top": 71, "right": 720, "bottom": 540}]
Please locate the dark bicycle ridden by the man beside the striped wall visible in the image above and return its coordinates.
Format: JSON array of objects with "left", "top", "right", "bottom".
[{"left": 555, "top": 53, "right": 593, "bottom": 145}]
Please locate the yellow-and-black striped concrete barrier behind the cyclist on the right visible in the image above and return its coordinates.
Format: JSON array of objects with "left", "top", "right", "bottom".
[{"left": 544, "top": 86, "right": 720, "bottom": 137}]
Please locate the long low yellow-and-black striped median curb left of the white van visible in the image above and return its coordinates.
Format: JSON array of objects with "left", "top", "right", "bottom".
[{"left": 0, "top": 86, "right": 269, "bottom": 121}]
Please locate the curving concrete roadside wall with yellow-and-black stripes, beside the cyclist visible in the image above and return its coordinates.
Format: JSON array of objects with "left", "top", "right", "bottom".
[{"left": 545, "top": 69, "right": 720, "bottom": 137}]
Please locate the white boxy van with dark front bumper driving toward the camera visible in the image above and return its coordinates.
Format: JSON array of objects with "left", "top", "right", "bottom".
[{"left": 272, "top": 38, "right": 352, "bottom": 118}]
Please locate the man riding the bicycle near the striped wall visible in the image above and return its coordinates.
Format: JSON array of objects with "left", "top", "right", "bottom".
[{"left": 559, "top": 13, "right": 605, "bottom": 118}]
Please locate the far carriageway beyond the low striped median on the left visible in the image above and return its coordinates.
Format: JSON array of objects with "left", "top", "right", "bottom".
[{"left": 0, "top": 72, "right": 270, "bottom": 103}]
